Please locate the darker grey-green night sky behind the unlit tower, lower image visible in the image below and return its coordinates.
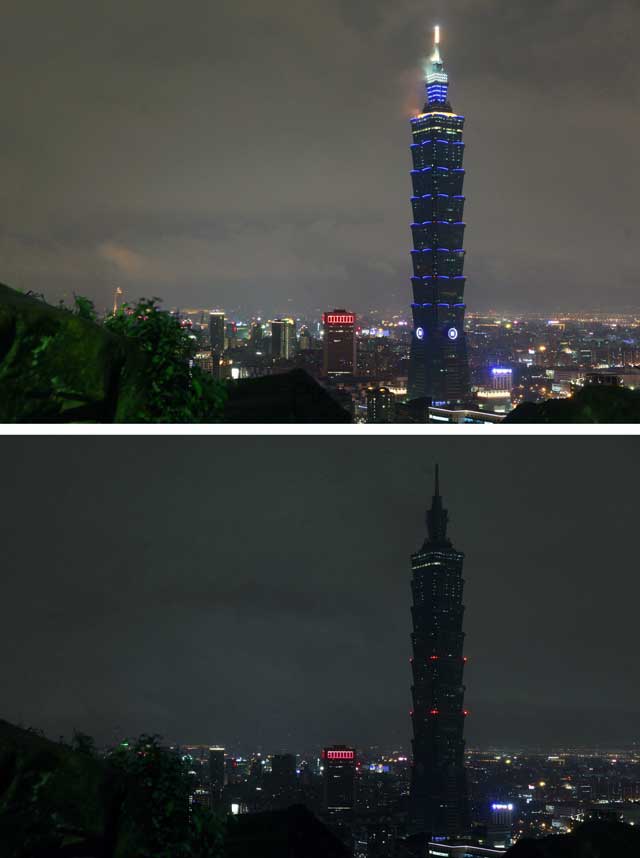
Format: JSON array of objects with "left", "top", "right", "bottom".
[{"left": 5, "top": 437, "right": 640, "bottom": 751}]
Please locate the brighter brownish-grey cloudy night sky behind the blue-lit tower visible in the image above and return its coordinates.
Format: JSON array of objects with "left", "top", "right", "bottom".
[{"left": 0, "top": 0, "right": 640, "bottom": 316}]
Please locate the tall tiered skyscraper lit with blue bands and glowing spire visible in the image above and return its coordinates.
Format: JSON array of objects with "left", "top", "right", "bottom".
[{"left": 409, "top": 27, "right": 469, "bottom": 406}]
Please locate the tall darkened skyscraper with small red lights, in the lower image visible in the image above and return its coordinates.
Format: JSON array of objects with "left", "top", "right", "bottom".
[{"left": 410, "top": 466, "right": 468, "bottom": 837}]
